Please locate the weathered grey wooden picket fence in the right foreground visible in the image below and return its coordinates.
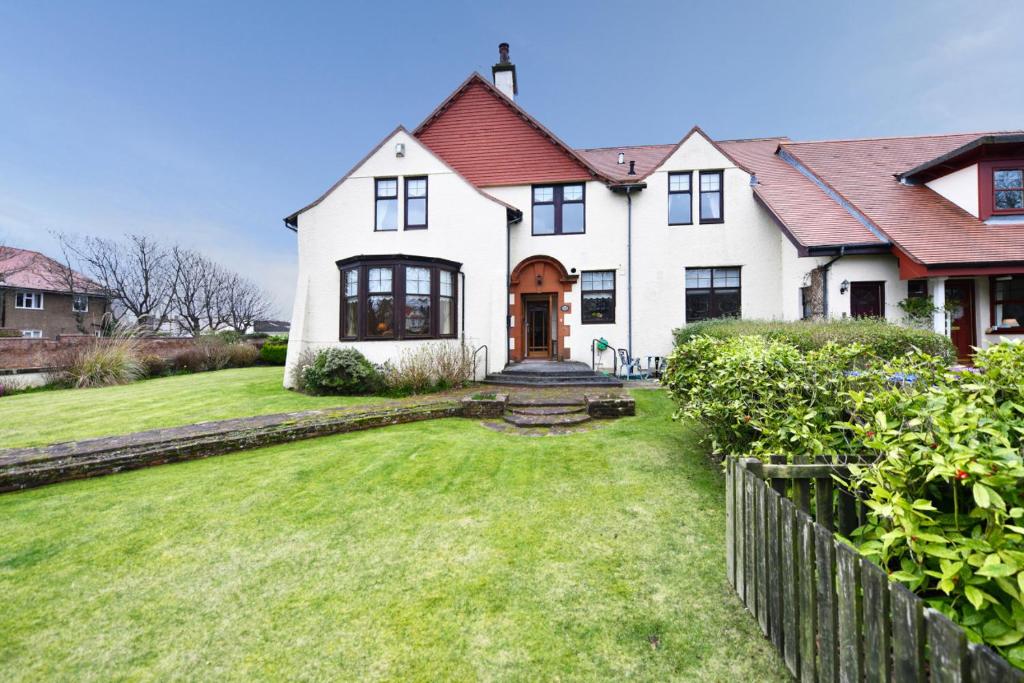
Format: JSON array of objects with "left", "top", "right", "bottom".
[{"left": 726, "top": 458, "right": 1024, "bottom": 683}]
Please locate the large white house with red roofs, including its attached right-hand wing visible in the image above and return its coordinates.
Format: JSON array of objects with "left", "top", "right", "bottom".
[{"left": 285, "top": 44, "right": 1024, "bottom": 385}]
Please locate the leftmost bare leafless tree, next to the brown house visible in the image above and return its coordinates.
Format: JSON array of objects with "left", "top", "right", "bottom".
[{"left": 59, "top": 234, "right": 177, "bottom": 328}]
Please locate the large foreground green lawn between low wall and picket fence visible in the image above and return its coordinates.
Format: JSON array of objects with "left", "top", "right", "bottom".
[{"left": 0, "top": 391, "right": 785, "bottom": 681}]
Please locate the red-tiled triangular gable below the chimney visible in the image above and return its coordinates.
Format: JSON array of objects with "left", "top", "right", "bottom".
[{"left": 413, "top": 74, "right": 603, "bottom": 187}]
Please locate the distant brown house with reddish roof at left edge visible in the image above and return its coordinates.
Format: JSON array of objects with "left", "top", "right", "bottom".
[{"left": 0, "top": 247, "right": 110, "bottom": 338}]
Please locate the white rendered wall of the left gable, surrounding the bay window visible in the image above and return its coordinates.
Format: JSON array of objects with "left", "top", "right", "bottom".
[{"left": 286, "top": 131, "right": 507, "bottom": 386}]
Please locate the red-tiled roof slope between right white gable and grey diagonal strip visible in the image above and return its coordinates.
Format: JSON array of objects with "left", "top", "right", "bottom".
[{"left": 719, "top": 137, "right": 886, "bottom": 248}]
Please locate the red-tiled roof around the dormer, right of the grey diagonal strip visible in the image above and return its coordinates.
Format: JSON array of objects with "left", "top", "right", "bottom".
[{"left": 781, "top": 133, "right": 1024, "bottom": 265}]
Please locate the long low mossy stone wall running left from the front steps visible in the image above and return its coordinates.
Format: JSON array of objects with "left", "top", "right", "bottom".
[{"left": 0, "top": 398, "right": 464, "bottom": 492}]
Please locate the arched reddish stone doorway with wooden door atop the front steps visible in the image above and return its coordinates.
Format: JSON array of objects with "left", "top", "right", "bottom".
[{"left": 509, "top": 255, "right": 578, "bottom": 360}]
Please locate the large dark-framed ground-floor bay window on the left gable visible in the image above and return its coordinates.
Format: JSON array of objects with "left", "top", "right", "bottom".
[{"left": 338, "top": 256, "right": 461, "bottom": 340}]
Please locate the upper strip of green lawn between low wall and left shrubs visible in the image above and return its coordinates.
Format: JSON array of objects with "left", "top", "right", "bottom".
[{"left": 0, "top": 368, "right": 383, "bottom": 449}]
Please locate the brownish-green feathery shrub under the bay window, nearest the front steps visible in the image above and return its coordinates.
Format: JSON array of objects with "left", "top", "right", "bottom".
[{"left": 382, "top": 342, "right": 473, "bottom": 395}]
